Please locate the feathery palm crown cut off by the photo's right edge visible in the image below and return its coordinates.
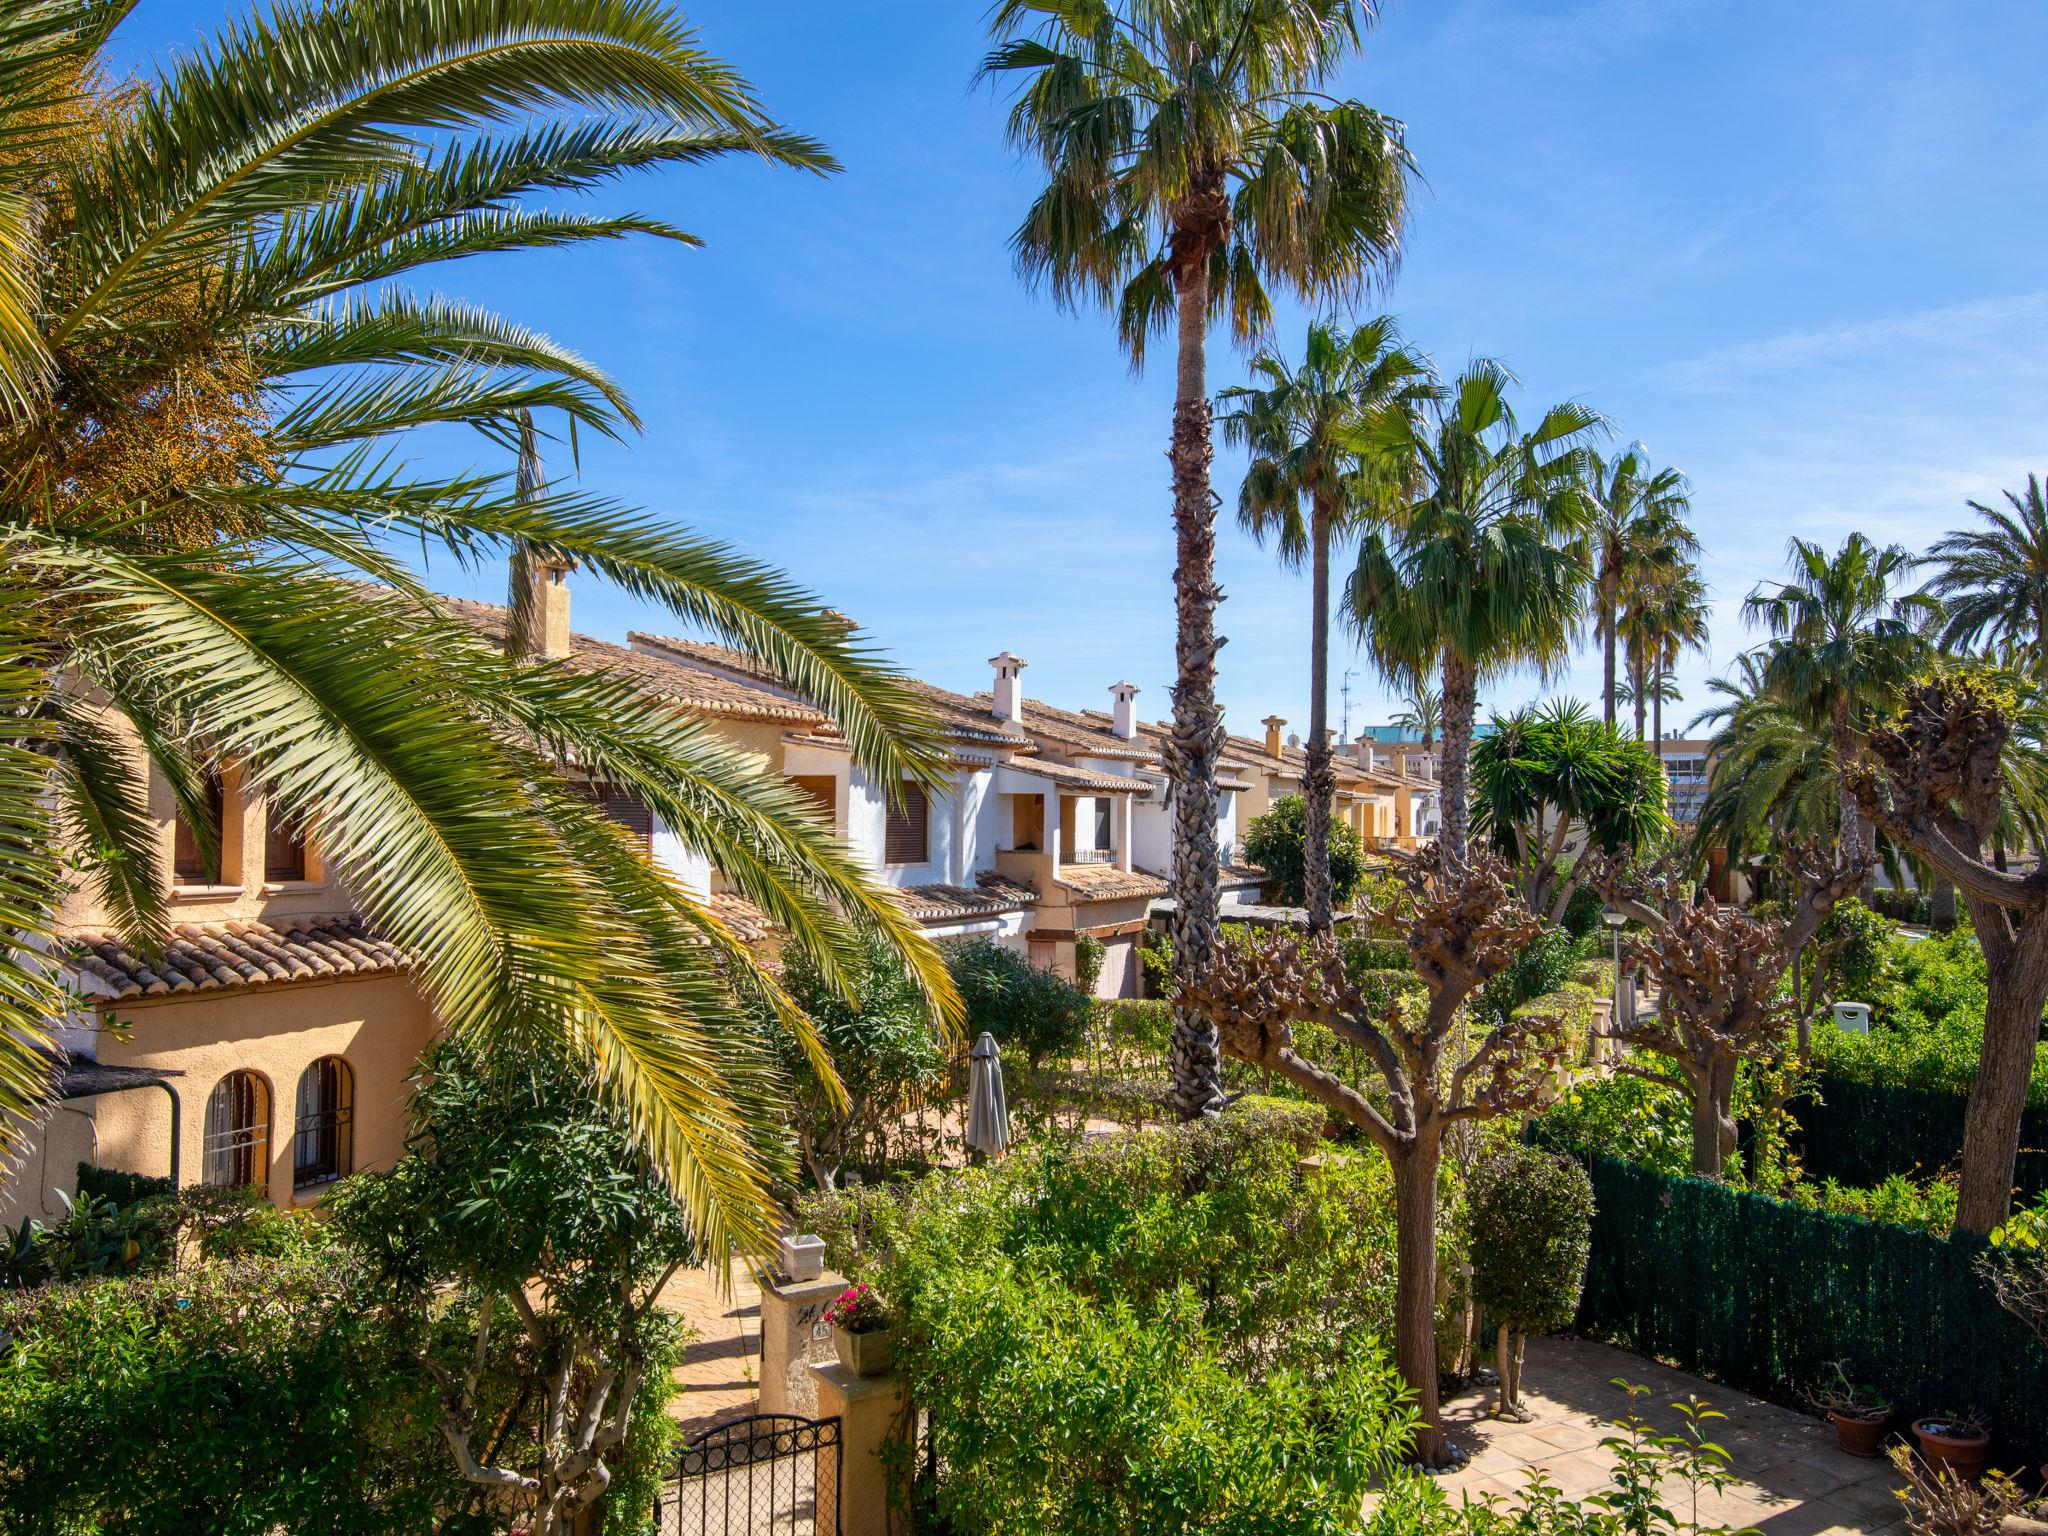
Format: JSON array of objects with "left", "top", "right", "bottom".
[{"left": 1927, "top": 475, "right": 2048, "bottom": 684}]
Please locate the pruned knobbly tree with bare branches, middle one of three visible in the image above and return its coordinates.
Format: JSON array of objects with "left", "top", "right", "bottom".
[{"left": 1589, "top": 846, "right": 1862, "bottom": 1178}]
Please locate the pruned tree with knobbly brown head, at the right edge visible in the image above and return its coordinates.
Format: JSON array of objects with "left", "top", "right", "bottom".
[{"left": 1849, "top": 670, "right": 2048, "bottom": 1233}]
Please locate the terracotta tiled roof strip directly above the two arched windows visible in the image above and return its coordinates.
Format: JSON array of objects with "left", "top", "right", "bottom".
[{"left": 66, "top": 918, "right": 406, "bottom": 1001}]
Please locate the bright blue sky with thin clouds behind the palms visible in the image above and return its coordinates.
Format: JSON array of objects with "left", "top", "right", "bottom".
[{"left": 108, "top": 0, "right": 2048, "bottom": 745}]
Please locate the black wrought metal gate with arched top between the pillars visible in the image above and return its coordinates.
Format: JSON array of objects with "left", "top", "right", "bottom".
[{"left": 653, "top": 1413, "right": 844, "bottom": 1536}]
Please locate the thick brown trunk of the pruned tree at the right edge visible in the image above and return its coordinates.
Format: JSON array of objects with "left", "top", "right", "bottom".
[{"left": 1956, "top": 925, "right": 2048, "bottom": 1233}]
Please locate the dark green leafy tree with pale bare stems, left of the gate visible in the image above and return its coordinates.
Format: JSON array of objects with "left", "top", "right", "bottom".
[{"left": 328, "top": 1036, "right": 698, "bottom": 1536}]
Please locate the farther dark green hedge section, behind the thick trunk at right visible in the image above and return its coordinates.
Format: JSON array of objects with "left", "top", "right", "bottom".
[{"left": 1790, "top": 1073, "right": 2048, "bottom": 1204}]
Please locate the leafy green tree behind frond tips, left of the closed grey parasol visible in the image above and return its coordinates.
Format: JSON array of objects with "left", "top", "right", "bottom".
[{"left": 760, "top": 934, "right": 946, "bottom": 1190}]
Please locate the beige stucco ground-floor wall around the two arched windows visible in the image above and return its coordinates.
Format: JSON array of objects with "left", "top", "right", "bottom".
[{"left": 0, "top": 977, "right": 434, "bottom": 1221}]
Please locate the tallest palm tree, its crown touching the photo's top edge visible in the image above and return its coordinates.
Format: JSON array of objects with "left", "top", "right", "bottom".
[{"left": 981, "top": 0, "right": 1413, "bottom": 1116}]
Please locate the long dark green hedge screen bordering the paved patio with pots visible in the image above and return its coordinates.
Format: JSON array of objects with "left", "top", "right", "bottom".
[{"left": 1579, "top": 1155, "right": 2048, "bottom": 1464}]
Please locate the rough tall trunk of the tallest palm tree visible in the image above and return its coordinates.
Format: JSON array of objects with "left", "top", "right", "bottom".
[{"left": 1165, "top": 198, "right": 1229, "bottom": 1120}]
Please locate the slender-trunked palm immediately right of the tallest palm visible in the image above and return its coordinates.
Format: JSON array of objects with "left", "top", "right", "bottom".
[{"left": 1219, "top": 315, "right": 1432, "bottom": 934}]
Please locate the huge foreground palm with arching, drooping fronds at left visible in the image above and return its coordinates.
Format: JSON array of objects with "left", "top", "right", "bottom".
[{"left": 0, "top": 0, "right": 954, "bottom": 1247}]
